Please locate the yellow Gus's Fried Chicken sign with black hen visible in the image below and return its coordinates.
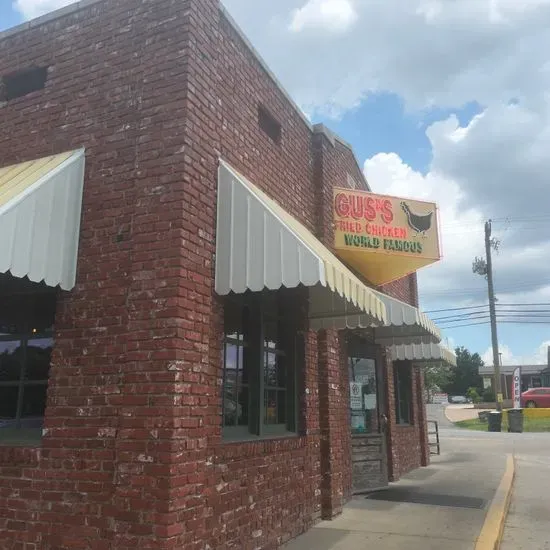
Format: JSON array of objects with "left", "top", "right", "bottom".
[{"left": 333, "top": 188, "right": 440, "bottom": 285}]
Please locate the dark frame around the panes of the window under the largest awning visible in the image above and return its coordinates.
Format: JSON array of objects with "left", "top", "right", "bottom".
[{"left": 222, "top": 291, "right": 305, "bottom": 442}]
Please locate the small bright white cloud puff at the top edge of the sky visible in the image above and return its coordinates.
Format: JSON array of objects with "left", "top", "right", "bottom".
[{"left": 289, "top": 0, "right": 357, "bottom": 33}]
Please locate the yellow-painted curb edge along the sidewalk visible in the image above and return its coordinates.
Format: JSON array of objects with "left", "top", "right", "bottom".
[{"left": 475, "top": 455, "right": 516, "bottom": 550}]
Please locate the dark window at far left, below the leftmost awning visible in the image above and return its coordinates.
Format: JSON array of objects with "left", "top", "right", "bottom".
[{"left": 0, "top": 286, "right": 56, "bottom": 443}]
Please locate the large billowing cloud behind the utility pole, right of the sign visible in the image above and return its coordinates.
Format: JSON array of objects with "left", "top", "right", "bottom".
[{"left": 365, "top": 105, "right": 550, "bottom": 307}]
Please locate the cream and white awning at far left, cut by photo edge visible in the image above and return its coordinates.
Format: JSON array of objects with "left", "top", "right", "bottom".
[{"left": 0, "top": 150, "right": 84, "bottom": 290}]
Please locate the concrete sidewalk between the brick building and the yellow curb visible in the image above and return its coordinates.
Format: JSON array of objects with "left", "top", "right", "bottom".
[{"left": 284, "top": 450, "right": 506, "bottom": 550}]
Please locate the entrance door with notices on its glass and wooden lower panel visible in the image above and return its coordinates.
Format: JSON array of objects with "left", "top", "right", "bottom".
[{"left": 348, "top": 341, "right": 388, "bottom": 494}]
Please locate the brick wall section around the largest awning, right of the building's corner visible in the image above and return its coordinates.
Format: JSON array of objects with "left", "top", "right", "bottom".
[{"left": 186, "top": 1, "right": 332, "bottom": 548}]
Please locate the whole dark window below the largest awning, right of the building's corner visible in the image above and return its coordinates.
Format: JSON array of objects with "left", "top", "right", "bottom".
[{"left": 223, "top": 293, "right": 298, "bottom": 439}]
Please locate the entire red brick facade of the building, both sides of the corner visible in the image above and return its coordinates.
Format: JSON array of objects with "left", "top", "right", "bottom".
[{"left": 0, "top": 0, "right": 428, "bottom": 550}]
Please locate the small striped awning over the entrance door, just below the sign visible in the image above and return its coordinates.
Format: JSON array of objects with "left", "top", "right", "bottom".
[{"left": 374, "top": 292, "right": 441, "bottom": 346}]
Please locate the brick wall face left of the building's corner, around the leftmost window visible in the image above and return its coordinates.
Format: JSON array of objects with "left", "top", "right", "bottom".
[{"left": 0, "top": 0, "right": 209, "bottom": 549}]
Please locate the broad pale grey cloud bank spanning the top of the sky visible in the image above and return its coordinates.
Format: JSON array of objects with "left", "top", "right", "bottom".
[{"left": 224, "top": 0, "right": 550, "bottom": 116}]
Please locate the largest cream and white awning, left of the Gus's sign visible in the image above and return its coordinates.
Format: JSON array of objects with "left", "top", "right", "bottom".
[{"left": 215, "top": 162, "right": 387, "bottom": 330}]
